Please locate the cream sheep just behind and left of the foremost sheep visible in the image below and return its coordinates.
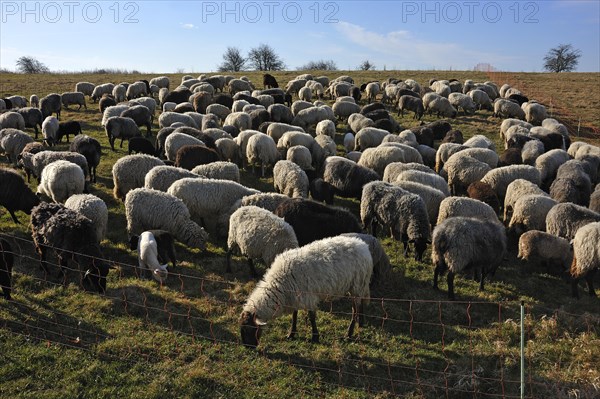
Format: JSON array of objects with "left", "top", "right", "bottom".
[{"left": 226, "top": 206, "right": 298, "bottom": 277}]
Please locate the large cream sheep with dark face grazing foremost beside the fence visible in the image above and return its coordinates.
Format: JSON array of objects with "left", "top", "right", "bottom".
[{"left": 240, "top": 237, "right": 373, "bottom": 348}]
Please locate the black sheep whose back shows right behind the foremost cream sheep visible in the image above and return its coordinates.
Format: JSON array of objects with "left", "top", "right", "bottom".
[{"left": 274, "top": 198, "right": 363, "bottom": 246}]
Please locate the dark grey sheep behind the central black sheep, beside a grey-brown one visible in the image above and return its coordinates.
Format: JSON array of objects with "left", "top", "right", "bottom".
[{"left": 323, "top": 157, "right": 379, "bottom": 198}]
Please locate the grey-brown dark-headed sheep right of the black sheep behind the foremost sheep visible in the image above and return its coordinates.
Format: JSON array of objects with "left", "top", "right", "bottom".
[{"left": 360, "top": 181, "right": 429, "bottom": 262}]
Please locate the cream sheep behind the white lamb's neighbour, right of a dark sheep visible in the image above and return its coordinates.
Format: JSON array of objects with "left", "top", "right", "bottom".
[{"left": 112, "top": 154, "right": 164, "bottom": 201}]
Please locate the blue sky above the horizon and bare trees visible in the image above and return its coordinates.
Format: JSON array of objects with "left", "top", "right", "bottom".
[{"left": 0, "top": 0, "right": 600, "bottom": 73}]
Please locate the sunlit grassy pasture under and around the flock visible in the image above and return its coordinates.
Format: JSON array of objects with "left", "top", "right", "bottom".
[{"left": 0, "top": 71, "right": 600, "bottom": 399}]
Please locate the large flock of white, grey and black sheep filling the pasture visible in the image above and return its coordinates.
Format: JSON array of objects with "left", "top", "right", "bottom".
[{"left": 0, "top": 74, "right": 600, "bottom": 346}]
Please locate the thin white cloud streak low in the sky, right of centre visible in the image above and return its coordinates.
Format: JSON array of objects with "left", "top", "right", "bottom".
[{"left": 336, "top": 21, "right": 516, "bottom": 69}]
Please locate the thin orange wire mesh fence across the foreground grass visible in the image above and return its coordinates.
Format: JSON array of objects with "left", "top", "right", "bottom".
[{"left": 0, "top": 236, "right": 600, "bottom": 398}]
